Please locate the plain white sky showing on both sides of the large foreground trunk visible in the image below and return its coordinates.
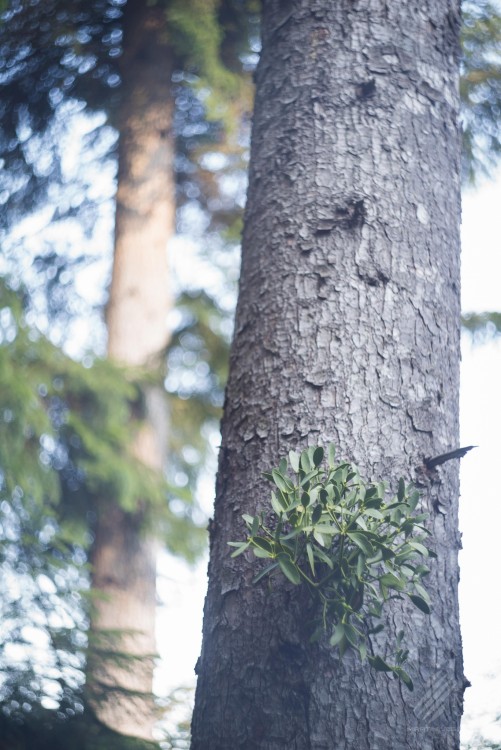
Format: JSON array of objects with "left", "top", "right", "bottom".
[{"left": 156, "top": 170, "right": 501, "bottom": 750}]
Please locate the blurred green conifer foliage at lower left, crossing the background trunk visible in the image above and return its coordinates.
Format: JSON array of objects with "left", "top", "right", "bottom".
[{"left": 0, "top": 281, "right": 209, "bottom": 748}]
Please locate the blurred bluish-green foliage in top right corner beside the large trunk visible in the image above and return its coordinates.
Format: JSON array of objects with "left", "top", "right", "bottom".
[{"left": 460, "top": 0, "right": 501, "bottom": 182}]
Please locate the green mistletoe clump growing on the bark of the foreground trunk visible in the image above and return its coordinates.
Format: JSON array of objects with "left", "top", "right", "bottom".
[{"left": 229, "top": 445, "right": 436, "bottom": 690}]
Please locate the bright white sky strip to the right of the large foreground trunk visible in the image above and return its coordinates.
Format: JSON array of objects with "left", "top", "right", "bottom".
[{"left": 460, "top": 171, "right": 501, "bottom": 741}]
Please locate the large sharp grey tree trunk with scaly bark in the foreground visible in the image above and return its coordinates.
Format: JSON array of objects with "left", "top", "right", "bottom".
[{"left": 192, "top": 0, "right": 464, "bottom": 750}]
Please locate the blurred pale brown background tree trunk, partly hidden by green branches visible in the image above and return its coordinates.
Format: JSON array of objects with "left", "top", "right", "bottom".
[{"left": 88, "top": 0, "right": 175, "bottom": 739}]
